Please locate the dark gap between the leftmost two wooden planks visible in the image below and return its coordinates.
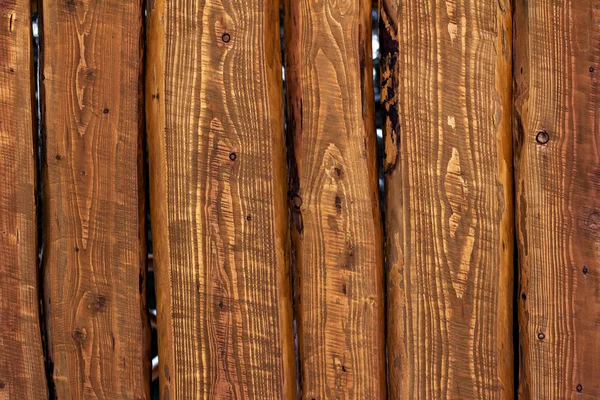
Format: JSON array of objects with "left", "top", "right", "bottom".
[{"left": 31, "top": 1, "right": 56, "bottom": 400}]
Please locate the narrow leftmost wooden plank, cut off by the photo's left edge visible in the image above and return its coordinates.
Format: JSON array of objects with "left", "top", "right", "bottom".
[{"left": 0, "top": 0, "right": 46, "bottom": 399}]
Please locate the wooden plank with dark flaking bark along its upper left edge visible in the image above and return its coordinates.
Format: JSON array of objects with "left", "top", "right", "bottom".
[{"left": 380, "top": 0, "right": 514, "bottom": 399}]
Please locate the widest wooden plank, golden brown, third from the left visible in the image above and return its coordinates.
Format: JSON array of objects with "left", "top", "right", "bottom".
[{"left": 146, "top": 0, "right": 296, "bottom": 399}]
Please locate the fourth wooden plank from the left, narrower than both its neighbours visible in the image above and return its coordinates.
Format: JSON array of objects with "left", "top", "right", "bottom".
[{"left": 285, "top": 0, "right": 386, "bottom": 399}]
